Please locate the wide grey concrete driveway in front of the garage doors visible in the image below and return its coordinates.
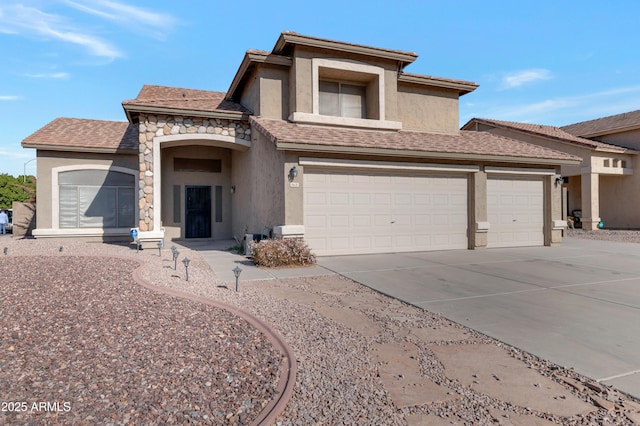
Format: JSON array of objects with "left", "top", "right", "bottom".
[{"left": 318, "top": 238, "right": 640, "bottom": 398}]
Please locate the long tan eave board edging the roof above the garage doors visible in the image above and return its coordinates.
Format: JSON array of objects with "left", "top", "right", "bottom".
[{"left": 276, "top": 141, "right": 582, "bottom": 166}]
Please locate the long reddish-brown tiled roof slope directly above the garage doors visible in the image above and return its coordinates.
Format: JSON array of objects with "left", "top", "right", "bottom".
[{"left": 250, "top": 117, "right": 581, "bottom": 164}]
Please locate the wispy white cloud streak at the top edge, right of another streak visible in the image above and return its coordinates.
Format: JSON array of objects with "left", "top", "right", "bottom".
[{"left": 62, "top": 0, "right": 178, "bottom": 39}]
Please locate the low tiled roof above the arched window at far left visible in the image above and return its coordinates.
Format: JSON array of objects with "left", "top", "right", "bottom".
[{"left": 22, "top": 117, "right": 138, "bottom": 153}]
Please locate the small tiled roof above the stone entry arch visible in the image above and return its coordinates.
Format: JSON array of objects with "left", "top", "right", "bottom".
[{"left": 122, "top": 84, "right": 247, "bottom": 113}]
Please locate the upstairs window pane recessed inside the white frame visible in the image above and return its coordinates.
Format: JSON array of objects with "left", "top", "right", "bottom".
[{"left": 319, "top": 81, "right": 367, "bottom": 118}]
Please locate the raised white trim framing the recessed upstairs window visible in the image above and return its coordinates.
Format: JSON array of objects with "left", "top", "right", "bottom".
[{"left": 290, "top": 58, "right": 402, "bottom": 130}]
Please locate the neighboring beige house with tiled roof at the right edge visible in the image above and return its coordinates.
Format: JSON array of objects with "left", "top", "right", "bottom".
[{"left": 462, "top": 116, "right": 640, "bottom": 230}]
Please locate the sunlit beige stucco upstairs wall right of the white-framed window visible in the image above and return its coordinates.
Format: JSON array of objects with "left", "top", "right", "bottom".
[{"left": 397, "top": 84, "right": 459, "bottom": 134}]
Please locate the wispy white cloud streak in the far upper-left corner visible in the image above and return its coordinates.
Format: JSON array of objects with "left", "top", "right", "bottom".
[{"left": 0, "top": 4, "right": 122, "bottom": 59}]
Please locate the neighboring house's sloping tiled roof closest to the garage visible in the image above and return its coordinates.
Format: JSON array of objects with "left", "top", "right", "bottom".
[{"left": 462, "top": 118, "right": 627, "bottom": 152}]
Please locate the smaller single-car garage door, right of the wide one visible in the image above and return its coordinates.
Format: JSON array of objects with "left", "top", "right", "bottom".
[{"left": 487, "top": 176, "right": 544, "bottom": 247}]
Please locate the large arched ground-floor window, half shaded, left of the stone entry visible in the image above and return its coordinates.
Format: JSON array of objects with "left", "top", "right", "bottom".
[{"left": 58, "top": 170, "right": 136, "bottom": 228}]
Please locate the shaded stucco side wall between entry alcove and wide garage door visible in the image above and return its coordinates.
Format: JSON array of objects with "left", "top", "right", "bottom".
[{"left": 231, "top": 131, "right": 286, "bottom": 240}]
